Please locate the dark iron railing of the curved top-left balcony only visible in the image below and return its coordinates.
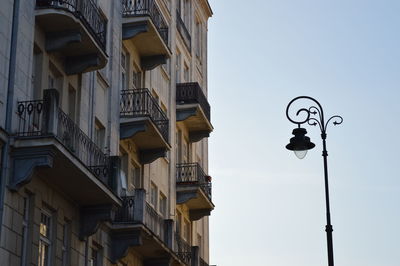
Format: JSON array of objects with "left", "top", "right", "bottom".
[{"left": 36, "top": 0, "right": 107, "bottom": 52}]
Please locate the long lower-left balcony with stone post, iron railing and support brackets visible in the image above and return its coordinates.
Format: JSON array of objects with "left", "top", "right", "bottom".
[{"left": 12, "top": 89, "right": 121, "bottom": 239}]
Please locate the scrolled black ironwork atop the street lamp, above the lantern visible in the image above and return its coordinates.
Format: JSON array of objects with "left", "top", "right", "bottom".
[{"left": 286, "top": 96, "right": 343, "bottom": 134}]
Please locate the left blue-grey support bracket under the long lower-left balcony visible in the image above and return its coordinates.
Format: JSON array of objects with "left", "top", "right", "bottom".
[{"left": 9, "top": 147, "right": 55, "bottom": 191}]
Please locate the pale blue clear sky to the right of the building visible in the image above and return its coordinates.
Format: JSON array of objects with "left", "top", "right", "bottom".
[{"left": 208, "top": 0, "right": 400, "bottom": 266}]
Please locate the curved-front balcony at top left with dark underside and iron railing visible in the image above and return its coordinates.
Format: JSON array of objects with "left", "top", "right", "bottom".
[{"left": 36, "top": 0, "right": 107, "bottom": 75}]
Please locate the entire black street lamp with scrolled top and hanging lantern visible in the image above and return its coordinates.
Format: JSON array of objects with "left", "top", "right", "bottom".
[{"left": 286, "top": 96, "right": 343, "bottom": 266}]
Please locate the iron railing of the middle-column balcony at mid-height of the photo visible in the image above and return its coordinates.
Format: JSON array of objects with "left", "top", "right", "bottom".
[{"left": 120, "top": 89, "right": 169, "bottom": 142}]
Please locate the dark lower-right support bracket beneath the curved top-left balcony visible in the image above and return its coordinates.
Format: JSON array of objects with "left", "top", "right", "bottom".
[{"left": 65, "top": 54, "right": 100, "bottom": 75}]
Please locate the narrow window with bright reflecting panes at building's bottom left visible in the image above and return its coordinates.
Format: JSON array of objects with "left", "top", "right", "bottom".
[{"left": 38, "top": 211, "right": 52, "bottom": 266}]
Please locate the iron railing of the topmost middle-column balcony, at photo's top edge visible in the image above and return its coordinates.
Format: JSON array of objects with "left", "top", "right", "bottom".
[{"left": 122, "top": 0, "right": 168, "bottom": 46}]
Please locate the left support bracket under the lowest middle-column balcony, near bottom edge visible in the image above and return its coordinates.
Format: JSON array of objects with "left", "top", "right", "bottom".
[{"left": 110, "top": 229, "right": 143, "bottom": 264}]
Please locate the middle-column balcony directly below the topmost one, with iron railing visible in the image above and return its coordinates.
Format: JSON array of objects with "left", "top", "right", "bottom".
[{"left": 120, "top": 89, "right": 171, "bottom": 164}]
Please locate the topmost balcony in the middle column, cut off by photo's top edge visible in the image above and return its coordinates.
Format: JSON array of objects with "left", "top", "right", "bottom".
[{"left": 122, "top": 0, "right": 171, "bottom": 70}]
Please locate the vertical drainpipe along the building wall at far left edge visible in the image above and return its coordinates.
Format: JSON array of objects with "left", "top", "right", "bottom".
[{"left": 0, "top": 0, "right": 20, "bottom": 235}]
